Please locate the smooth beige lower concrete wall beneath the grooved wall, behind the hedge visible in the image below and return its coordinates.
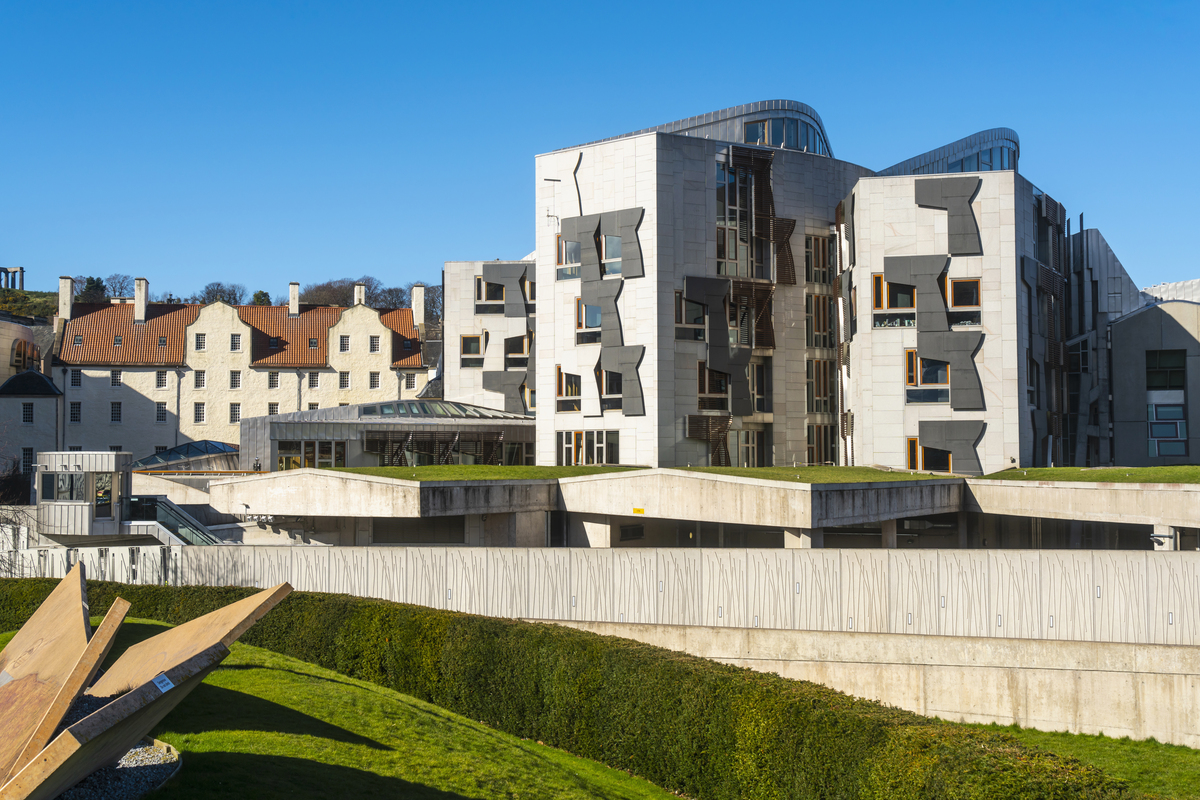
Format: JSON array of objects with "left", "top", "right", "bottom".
[{"left": 563, "top": 622, "right": 1200, "bottom": 747}]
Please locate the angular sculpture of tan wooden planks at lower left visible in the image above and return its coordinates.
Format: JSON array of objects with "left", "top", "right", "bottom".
[{"left": 0, "top": 564, "right": 292, "bottom": 800}]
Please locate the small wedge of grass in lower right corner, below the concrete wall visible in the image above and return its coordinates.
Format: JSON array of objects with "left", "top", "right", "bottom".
[{"left": 974, "top": 724, "right": 1200, "bottom": 800}]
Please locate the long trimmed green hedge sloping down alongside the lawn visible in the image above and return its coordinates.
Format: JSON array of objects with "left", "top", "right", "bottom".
[{"left": 0, "top": 579, "right": 1134, "bottom": 800}]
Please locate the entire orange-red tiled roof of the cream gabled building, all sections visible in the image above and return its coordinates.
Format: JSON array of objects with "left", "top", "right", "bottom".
[{"left": 58, "top": 303, "right": 422, "bottom": 368}]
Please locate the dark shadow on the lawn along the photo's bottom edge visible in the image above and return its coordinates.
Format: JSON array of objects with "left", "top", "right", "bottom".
[{"left": 154, "top": 752, "right": 468, "bottom": 800}]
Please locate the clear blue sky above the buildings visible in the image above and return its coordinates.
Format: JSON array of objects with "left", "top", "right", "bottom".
[{"left": 0, "top": 0, "right": 1200, "bottom": 295}]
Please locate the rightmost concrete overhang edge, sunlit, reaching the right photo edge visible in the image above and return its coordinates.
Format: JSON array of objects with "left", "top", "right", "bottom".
[{"left": 965, "top": 479, "right": 1200, "bottom": 528}]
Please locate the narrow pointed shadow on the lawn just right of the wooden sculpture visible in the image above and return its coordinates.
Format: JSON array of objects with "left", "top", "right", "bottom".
[{"left": 160, "top": 684, "right": 391, "bottom": 758}]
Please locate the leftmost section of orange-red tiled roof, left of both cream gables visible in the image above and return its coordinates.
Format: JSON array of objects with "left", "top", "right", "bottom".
[{"left": 58, "top": 302, "right": 202, "bottom": 367}]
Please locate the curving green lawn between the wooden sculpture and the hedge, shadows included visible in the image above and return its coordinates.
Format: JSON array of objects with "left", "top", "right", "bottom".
[{"left": 0, "top": 618, "right": 676, "bottom": 800}]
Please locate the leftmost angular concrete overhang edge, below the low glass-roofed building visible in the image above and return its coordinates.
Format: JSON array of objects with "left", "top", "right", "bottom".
[{"left": 209, "top": 469, "right": 558, "bottom": 517}]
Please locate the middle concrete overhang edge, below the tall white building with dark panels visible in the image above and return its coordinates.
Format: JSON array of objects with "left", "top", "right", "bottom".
[{"left": 558, "top": 469, "right": 962, "bottom": 528}]
